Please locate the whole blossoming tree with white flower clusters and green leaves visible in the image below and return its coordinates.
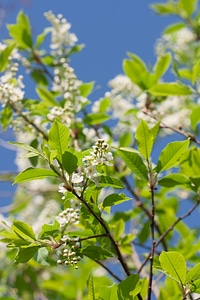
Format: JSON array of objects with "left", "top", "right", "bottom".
[{"left": 0, "top": 0, "right": 200, "bottom": 300}]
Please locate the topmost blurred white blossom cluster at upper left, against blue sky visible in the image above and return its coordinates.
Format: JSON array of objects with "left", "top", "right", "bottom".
[{"left": 44, "top": 11, "right": 78, "bottom": 56}]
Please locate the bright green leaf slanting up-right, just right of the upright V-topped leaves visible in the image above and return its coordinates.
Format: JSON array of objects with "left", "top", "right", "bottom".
[{"left": 156, "top": 140, "right": 190, "bottom": 173}]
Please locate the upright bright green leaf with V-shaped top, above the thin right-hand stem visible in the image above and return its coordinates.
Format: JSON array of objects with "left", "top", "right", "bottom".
[{"left": 135, "top": 120, "right": 160, "bottom": 160}]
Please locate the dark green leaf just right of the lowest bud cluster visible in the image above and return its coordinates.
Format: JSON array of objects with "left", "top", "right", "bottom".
[{"left": 82, "top": 246, "right": 113, "bottom": 260}]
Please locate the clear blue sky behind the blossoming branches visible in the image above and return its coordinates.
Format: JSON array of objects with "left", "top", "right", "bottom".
[{"left": 0, "top": 0, "right": 180, "bottom": 211}]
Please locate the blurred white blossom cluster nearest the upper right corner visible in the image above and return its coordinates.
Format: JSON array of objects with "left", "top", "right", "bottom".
[{"left": 155, "top": 27, "right": 196, "bottom": 60}]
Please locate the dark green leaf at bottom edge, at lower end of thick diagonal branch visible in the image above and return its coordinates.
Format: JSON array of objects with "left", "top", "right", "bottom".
[{"left": 117, "top": 274, "right": 141, "bottom": 300}]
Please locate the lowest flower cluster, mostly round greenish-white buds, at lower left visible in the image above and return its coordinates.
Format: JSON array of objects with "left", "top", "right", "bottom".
[{"left": 57, "top": 235, "right": 81, "bottom": 269}]
